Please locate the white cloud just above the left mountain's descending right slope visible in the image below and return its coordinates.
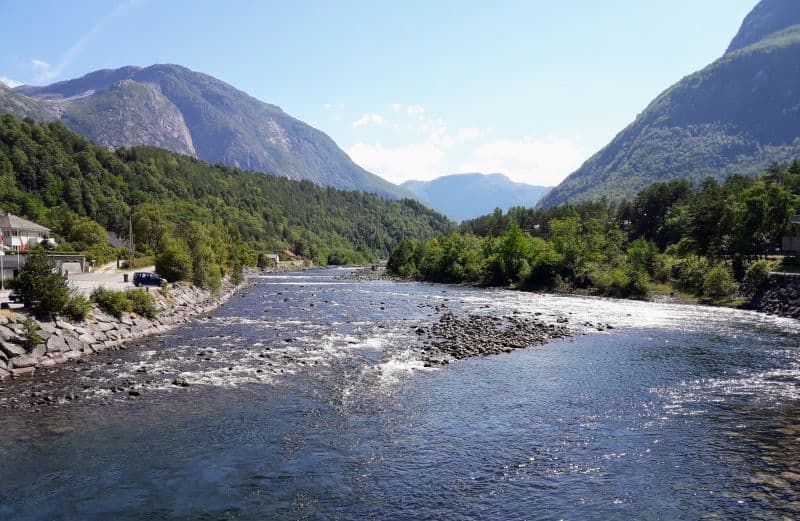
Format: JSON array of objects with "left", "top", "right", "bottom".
[{"left": 347, "top": 141, "right": 444, "bottom": 183}]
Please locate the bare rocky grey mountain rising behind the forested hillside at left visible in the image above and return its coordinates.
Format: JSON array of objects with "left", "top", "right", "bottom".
[{"left": 0, "top": 65, "right": 410, "bottom": 198}]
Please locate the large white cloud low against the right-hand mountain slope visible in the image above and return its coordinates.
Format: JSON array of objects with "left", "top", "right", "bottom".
[{"left": 459, "top": 136, "right": 587, "bottom": 186}]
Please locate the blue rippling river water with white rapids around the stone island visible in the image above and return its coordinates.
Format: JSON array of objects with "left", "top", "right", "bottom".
[{"left": 0, "top": 270, "right": 800, "bottom": 520}]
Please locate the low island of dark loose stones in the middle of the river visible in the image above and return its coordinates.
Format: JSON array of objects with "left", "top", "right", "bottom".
[{"left": 416, "top": 312, "right": 571, "bottom": 364}]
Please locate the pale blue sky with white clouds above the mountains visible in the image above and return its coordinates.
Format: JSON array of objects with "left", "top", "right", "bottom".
[{"left": 0, "top": 0, "right": 756, "bottom": 186}]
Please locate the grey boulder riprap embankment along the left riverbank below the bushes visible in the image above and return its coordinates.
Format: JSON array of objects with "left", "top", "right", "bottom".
[{"left": 0, "top": 282, "right": 236, "bottom": 380}]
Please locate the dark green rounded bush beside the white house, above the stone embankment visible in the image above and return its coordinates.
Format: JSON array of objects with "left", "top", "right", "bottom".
[{"left": 14, "top": 251, "right": 69, "bottom": 318}]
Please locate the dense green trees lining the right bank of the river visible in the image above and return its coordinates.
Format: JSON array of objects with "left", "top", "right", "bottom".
[{"left": 388, "top": 161, "right": 800, "bottom": 301}]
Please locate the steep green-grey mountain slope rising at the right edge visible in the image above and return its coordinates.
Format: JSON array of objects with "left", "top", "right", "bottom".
[{"left": 542, "top": 0, "right": 800, "bottom": 206}]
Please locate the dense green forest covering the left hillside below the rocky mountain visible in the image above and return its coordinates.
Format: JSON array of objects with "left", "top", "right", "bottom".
[{"left": 0, "top": 115, "right": 453, "bottom": 284}]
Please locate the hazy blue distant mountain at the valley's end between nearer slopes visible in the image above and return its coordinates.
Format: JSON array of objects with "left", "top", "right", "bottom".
[{"left": 400, "top": 174, "right": 550, "bottom": 221}]
